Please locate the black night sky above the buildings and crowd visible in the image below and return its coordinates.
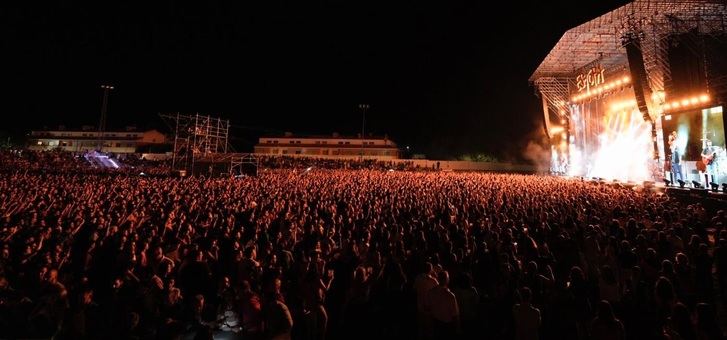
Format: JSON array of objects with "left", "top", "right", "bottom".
[{"left": 0, "top": 0, "right": 625, "bottom": 158}]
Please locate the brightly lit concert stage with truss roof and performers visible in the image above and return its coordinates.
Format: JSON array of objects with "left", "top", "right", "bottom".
[{"left": 530, "top": 0, "right": 727, "bottom": 185}]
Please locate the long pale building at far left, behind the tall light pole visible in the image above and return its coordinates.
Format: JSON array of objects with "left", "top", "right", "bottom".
[{"left": 28, "top": 126, "right": 167, "bottom": 154}]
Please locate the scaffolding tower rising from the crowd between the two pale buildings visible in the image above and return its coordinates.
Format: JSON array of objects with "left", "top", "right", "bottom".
[{"left": 159, "top": 113, "right": 230, "bottom": 174}]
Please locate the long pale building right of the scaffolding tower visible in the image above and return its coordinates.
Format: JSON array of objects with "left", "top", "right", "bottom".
[{"left": 255, "top": 133, "right": 399, "bottom": 159}]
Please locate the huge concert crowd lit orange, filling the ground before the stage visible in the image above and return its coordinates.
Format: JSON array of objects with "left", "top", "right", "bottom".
[{"left": 0, "top": 150, "right": 727, "bottom": 340}]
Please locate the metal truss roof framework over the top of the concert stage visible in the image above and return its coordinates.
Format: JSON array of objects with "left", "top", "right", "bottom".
[{"left": 530, "top": 0, "right": 727, "bottom": 114}]
